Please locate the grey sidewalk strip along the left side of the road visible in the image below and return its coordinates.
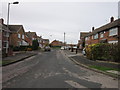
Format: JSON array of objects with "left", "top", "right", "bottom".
[{"left": 2, "top": 51, "right": 40, "bottom": 66}]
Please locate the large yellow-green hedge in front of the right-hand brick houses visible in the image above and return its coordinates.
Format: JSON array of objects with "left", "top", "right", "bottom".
[{"left": 86, "top": 43, "right": 120, "bottom": 62}]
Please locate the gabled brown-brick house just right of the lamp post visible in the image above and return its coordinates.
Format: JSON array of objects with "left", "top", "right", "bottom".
[{"left": 9, "top": 25, "right": 29, "bottom": 47}]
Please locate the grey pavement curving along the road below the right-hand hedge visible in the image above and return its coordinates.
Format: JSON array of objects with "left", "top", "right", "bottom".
[{"left": 64, "top": 50, "right": 120, "bottom": 78}]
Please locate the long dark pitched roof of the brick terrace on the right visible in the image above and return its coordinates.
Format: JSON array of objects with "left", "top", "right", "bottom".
[{"left": 86, "top": 19, "right": 120, "bottom": 37}]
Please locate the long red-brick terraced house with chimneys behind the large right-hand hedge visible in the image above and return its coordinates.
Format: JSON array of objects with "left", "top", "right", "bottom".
[{"left": 85, "top": 17, "right": 120, "bottom": 45}]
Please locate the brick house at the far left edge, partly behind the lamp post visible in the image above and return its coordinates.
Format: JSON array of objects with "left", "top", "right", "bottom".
[{"left": 0, "top": 19, "right": 12, "bottom": 57}]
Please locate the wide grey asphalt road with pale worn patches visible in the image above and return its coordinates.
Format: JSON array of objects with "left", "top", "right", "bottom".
[{"left": 2, "top": 50, "right": 118, "bottom": 88}]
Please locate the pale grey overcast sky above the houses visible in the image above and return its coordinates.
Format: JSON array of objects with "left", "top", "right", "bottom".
[{"left": 0, "top": 0, "right": 118, "bottom": 43}]
